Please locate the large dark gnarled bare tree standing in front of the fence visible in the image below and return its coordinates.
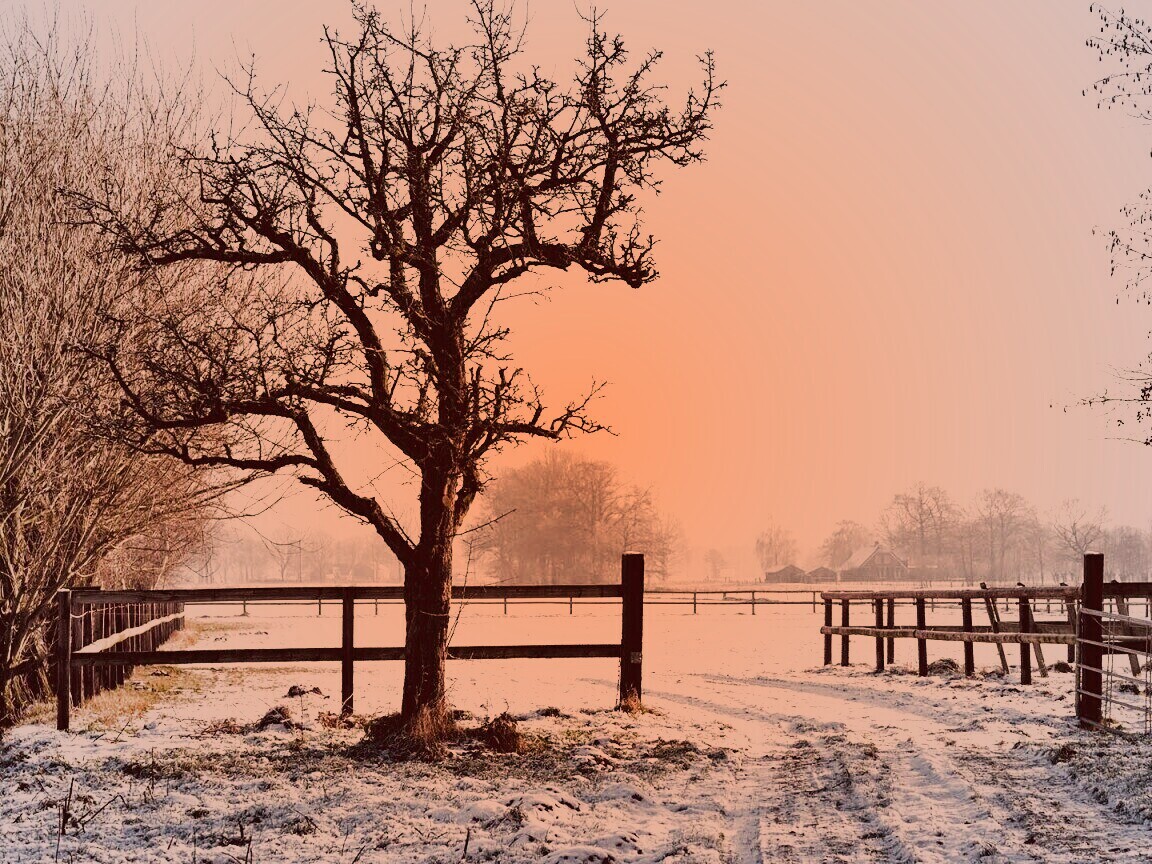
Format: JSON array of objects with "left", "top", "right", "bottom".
[{"left": 76, "top": 0, "right": 720, "bottom": 745}]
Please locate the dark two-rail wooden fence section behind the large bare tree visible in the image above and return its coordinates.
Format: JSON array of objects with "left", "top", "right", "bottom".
[{"left": 56, "top": 554, "right": 644, "bottom": 729}]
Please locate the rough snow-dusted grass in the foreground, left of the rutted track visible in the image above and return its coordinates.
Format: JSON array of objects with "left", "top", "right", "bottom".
[{"left": 0, "top": 706, "right": 733, "bottom": 864}]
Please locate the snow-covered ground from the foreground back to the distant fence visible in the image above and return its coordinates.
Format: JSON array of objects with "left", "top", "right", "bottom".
[{"left": 0, "top": 604, "right": 1152, "bottom": 864}]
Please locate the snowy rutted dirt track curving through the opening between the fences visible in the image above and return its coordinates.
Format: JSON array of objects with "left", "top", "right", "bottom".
[{"left": 651, "top": 675, "right": 1152, "bottom": 864}]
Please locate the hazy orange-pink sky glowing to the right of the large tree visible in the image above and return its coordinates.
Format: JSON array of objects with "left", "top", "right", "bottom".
[{"left": 27, "top": 0, "right": 1152, "bottom": 578}]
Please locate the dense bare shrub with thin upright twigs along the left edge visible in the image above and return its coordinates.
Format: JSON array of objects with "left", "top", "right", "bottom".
[{"left": 0, "top": 21, "right": 214, "bottom": 727}]
